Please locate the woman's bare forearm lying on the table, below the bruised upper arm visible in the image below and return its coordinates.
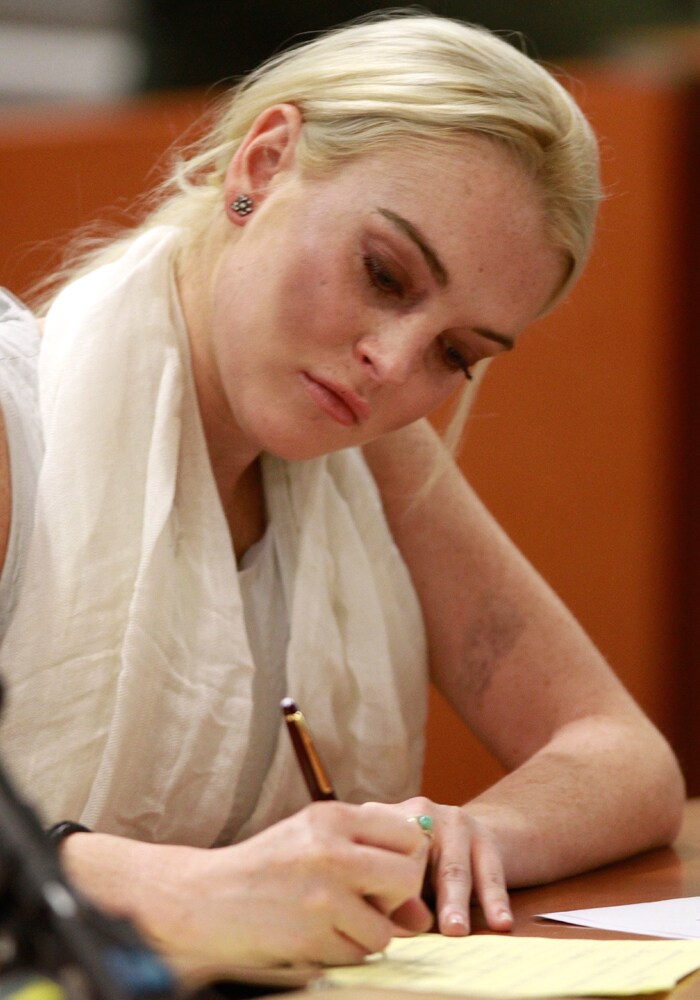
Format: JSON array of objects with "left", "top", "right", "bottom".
[{"left": 465, "top": 716, "right": 685, "bottom": 887}]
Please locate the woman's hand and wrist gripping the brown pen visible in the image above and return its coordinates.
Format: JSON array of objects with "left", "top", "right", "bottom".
[{"left": 64, "top": 802, "right": 432, "bottom": 969}]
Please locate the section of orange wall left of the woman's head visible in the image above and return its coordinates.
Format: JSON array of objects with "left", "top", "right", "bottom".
[{"left": 0, "top": 94, "right": 211, "bottom": 295}]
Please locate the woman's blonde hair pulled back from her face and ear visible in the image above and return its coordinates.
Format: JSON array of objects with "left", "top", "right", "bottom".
[{"left": 42, "top": 10, "right": 600, "bottom": 305}]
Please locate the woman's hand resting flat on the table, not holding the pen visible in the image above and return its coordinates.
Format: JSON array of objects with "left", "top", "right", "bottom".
[{"left": 394, "top": 797, "right": 513, "bottom": 936}]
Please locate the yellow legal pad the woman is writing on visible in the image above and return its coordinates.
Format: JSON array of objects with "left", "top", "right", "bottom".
[{"left": 324, "top": 934, "right": 700, "bottom": 1000}]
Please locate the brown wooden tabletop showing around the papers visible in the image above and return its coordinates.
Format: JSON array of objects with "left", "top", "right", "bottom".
[{"left": 249, "top": 799, "right": 700, "bottom": 1000}]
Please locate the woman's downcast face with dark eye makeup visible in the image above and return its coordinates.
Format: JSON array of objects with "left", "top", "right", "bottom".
[{"left": 195, "top": 131, "right": 564, "bottom": 459}]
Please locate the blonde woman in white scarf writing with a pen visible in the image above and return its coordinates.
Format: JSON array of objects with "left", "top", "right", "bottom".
[{"left": 0, "top": 15, "right": 683, "bottom": 964}]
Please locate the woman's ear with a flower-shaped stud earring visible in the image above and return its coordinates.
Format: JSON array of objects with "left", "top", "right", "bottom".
[{"left": 224, "top": 104, "right": 303, "bottom": 225}]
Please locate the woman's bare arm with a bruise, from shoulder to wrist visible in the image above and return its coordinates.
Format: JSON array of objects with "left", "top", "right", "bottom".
[{"left": 365, "top": 414, "right": 684, "bottom": 910}]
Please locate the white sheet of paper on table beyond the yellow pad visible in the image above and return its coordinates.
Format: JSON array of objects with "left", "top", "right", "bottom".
[{"left": 537, "top": 896, "right": 700, "bottom": 940}]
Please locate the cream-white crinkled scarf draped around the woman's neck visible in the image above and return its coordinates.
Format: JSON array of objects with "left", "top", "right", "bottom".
[{"left": 0, "top": 227, "right": 426, "bottom": 845}]
